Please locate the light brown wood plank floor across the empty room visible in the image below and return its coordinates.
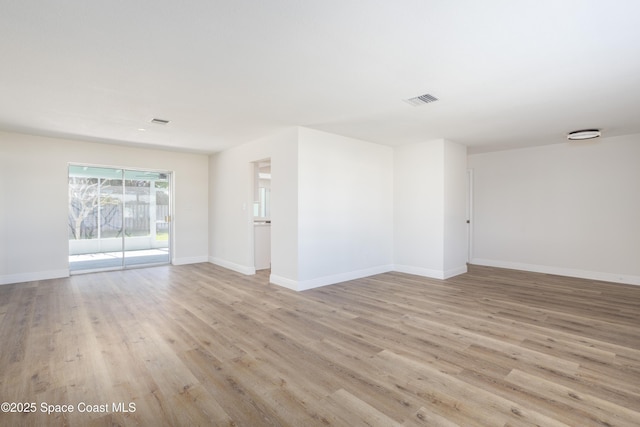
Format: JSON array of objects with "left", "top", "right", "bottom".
[{"left": 0, "top": 264, "right": 640, "bottom": 427}]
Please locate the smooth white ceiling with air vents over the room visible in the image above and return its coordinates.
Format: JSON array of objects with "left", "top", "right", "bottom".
[{"left": 0, "top": 0, "right": 640, "bottom": 152}]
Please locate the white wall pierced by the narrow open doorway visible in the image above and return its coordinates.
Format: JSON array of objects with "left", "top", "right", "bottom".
[{"left": 209, "top": 128, "right": 298, "bottom": 283}]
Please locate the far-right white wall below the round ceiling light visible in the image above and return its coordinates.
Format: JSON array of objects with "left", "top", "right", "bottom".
[{"left": 469, "top": 135, "right": 640, "bottom": 284}]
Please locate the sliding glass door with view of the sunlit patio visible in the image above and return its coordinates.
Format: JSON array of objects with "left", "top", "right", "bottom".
[{"left": 69, "top": 165, "right": 171, "bottom": 272}]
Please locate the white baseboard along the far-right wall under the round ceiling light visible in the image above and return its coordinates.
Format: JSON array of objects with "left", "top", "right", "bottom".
[{"left": 470, "top": 258, "right": 640, "bottom": 285}]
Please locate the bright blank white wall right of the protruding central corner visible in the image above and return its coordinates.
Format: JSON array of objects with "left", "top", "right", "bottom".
[{"left": 297, "top": 128, "right": 393, "bottom": 290}]
